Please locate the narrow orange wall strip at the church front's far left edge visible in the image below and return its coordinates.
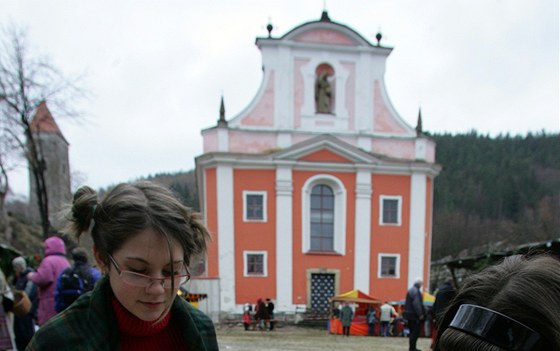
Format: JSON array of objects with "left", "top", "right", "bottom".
[{"left": 201, "top": 168, "right": 219, "bottom": 278}]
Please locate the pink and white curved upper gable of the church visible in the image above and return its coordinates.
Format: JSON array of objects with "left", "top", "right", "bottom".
[{"left": 202, "top": 11, "right": 435, "bottom": 164}]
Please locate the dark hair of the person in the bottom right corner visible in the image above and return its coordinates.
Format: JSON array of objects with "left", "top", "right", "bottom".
[{"left": 435, "top": 255, "right": 560, "bottom": 351}]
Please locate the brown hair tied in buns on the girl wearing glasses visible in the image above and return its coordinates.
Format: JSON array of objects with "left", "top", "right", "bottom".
[{"left": 66, "top": 181, "right": 210, "bottom": 266}]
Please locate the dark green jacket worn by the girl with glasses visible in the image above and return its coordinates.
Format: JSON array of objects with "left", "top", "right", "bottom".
[{"left": 26, "top": 277, "right": 218, "bottom": 351}]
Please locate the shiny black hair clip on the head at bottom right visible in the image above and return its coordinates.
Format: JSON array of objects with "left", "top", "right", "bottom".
[{"left": 449, "top": 304, "right": 544, "bottom": 351}]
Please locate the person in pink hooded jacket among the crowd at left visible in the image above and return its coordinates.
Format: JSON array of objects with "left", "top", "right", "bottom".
[{"left": 27, "top": 236, "right": 70, "bottom": 326}]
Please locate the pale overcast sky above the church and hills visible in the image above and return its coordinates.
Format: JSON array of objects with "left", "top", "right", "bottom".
[{"left": 0, "top": 0, "right": 560, "bottom": 195}]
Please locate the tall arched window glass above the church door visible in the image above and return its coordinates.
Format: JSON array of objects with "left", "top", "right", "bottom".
[{"left": 310, "top": 184, "right": 334, "bottom": 251}]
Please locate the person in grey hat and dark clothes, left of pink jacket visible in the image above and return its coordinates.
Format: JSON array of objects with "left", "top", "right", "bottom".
[{"left": 12, "top": 256, "right": 38, "bottom": 350}]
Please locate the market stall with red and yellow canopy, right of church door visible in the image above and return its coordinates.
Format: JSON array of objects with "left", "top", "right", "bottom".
[{"left": 329, "top": 289, "right": 381, "bottom": 335}]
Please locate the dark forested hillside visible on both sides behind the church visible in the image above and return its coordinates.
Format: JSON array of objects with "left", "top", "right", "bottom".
[{"left": 148, "top": 132, "right": 560, "bottom": 260}]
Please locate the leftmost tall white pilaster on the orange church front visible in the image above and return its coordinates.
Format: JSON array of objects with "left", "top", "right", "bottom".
[{"left": 216, "top": 164, "right": 235, "bottom": 312}]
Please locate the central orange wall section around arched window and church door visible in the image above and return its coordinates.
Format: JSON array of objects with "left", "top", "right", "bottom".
[{"left": 292, "top": 171, "right": 356, "bottom": 304}]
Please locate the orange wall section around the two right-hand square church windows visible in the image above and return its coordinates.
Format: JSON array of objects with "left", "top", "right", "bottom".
[{"left": 370, "top": 175, "right": 411, "bottom": 300}]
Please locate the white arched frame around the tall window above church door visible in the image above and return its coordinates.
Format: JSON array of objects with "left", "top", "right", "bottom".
[{"left": 301, "top": 174, "right": 346, "bottom": 255}]
